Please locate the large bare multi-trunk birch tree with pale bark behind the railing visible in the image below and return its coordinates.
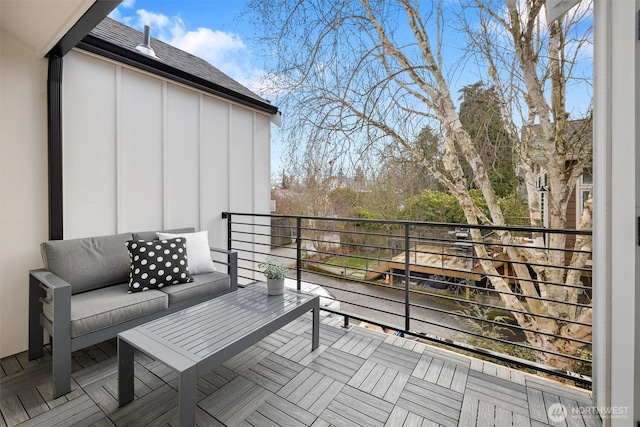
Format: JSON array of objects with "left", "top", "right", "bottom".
[{"left": 250, "top": 0, "right": 592, "bottom": 369}]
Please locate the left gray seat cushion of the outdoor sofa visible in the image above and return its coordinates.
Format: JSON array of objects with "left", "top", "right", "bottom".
[{"left": 71, "top": 283, "right": 169, "bottom": 338}]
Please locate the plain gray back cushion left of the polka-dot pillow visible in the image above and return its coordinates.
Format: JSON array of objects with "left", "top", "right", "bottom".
[{"left": 40, "top": 233, "right": 132, "bottom": 294}]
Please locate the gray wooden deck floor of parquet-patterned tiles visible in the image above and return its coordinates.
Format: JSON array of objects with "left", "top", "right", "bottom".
[{"left": 0, "top": 315, "right": 601, "bottom": 427}]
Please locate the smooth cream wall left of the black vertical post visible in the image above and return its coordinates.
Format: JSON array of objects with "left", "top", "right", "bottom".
[{"left": 0, "top": 33, "right": 48, "bottom": 357}]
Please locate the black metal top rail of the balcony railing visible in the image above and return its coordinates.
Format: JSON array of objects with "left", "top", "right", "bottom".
[{"left": 222, "top": 212, "right": 592, "bottom": 236}]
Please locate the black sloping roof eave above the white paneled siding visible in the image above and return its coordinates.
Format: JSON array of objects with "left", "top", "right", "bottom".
[{"left": 76, "top": 34, "right": 278, "bottom": 114}]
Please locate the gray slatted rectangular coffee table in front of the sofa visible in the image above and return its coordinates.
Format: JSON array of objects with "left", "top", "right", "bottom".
[{"left": 118, "top": 284, "right": 320, "bottom": 426}]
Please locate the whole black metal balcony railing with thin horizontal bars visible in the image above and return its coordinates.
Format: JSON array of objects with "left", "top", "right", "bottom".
[{"left": 223, "top": 212, "right": 592, "bottom": 386}]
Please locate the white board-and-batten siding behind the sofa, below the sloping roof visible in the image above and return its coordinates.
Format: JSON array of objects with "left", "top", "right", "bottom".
[{"left": 63, "top": 50, "right": 271, "bottom": 276}]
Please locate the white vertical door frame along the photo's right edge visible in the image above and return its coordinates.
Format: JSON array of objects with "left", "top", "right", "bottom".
[{"left": 593, "top": 0, "right": 640, "bottom": 426}]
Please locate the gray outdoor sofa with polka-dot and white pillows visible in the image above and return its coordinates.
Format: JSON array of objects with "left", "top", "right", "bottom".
[{"left": 29, "top": 228, "right": 238, "bottom": 398}]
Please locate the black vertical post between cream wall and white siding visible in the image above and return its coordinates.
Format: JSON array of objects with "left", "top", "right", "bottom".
[{"left": 47, "top": 55, "right": 64, "bottom": 240}]
